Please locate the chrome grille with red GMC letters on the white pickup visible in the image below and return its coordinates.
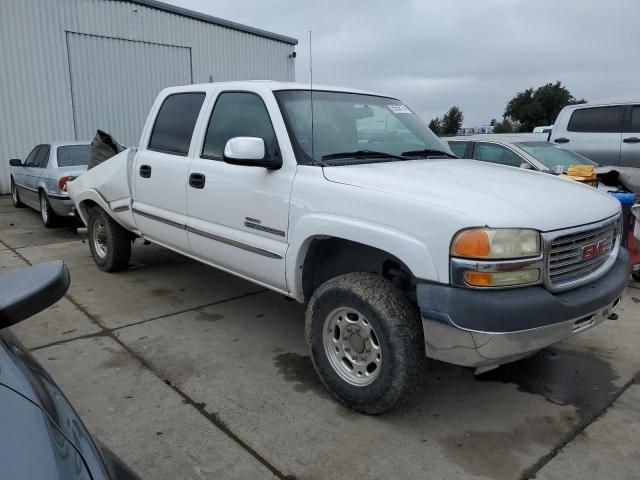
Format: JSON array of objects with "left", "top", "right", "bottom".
[{"left": 547, "top": 218, "right": 618, "bottom": 290}]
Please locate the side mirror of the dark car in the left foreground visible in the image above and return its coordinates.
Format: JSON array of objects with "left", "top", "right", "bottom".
[{"left": 0, "top": 260, "right": 70, "bottom": 329}]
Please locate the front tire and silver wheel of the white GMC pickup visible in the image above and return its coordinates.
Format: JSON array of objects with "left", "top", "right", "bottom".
[{"left": 305, "top": 273, "right": 426, "bottom": 414}]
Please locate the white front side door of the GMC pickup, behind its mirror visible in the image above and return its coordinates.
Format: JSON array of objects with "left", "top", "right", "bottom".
[{"left": 187, "top": 91, "right": 296, "bottom": 290}]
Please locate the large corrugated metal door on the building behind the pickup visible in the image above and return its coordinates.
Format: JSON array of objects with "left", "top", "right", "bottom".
[{"left": 67, "top": 32, "right": 192, "bottom": 146}]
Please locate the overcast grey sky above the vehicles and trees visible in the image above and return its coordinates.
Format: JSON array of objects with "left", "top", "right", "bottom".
[{"left": 165, "top": 0, "right": 640, "bottom": 126}]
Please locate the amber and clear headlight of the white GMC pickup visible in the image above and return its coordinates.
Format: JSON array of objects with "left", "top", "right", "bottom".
[{"left": 451, "top": 228, "right": 540, "bottom": 259}]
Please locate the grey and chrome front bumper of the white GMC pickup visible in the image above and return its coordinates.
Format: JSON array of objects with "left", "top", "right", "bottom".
[{"left": 417, "top": 248, "right": 629, "bottom": 367}]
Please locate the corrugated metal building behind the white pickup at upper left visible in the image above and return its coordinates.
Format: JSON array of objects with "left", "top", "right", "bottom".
[{"left": 0, "top": 0, "right": 297, "bottom": 193}]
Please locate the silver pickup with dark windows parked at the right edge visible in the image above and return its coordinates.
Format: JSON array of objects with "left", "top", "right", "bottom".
[{"left": 549, "top": 102, "right": 640, "bottom": 167}]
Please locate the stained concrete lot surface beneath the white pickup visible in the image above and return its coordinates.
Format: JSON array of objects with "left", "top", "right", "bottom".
[{"left": 0, "top": 197, "right": 640, "bottom": 480}]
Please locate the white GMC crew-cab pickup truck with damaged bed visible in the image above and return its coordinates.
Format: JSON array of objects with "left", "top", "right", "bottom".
[{"left": 68, "top": 82, "right": 629, "bottom": 414}]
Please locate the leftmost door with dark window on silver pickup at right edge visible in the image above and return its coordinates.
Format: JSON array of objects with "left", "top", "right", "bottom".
[{"left": 553, "top": 105, "right": 624, "bottom": 165}]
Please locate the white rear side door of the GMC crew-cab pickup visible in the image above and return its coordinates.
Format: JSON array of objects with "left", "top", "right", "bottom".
[{"left": 133, "top": 92, "right": 206, "bottom": 252}]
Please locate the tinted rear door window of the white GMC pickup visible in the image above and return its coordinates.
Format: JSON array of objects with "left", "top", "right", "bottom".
[{"left": 149, "top": 92, "right": 205, "bottom": 156}]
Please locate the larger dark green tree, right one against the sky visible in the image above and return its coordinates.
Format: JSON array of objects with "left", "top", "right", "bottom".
[{"left": 503, "top": 81, "right": 586, "bottom": 132}]
